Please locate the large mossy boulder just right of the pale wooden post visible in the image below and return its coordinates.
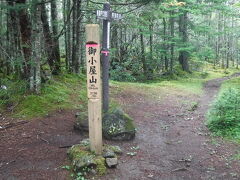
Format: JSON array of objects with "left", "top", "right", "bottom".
[{"left": 103, "top": 109, "right": 136, "bottom": 140}]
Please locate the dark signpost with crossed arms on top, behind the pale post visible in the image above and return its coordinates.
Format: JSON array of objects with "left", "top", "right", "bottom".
[{"left": 96, "top": 3, "right": 122, "bottom": 112}]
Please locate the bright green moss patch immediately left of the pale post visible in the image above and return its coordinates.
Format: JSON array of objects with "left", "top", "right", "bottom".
[{"left": 13, "top": 74, "right": 87, "bottom": 119}]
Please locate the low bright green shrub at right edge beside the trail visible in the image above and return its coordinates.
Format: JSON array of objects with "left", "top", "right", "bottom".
[{"left": 207, "top": 88, "right": 240, "bottom": 138}]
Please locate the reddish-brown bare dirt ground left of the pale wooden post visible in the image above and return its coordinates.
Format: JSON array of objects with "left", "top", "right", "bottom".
[{"left": 0, "top": 111, "right": 83, "bottom": 180}]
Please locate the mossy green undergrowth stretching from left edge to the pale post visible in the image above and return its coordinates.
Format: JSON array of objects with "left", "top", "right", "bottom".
[{"left": 0, "top": 74, "right": 87, "bottom": 119}]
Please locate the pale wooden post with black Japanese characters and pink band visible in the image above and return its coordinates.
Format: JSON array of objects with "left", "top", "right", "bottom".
[{"left": 86, "top": 24, "right": 102, "bottom": 154}]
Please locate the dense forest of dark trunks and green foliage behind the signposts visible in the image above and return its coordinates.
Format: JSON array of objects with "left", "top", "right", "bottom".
[{"left": 0, "top": 0, "right": 240, "bottom": 93}]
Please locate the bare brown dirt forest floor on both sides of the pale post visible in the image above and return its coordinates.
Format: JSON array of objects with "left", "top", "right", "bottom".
[{"left": 0, "top": 73, "right": 240, "bottom": 180}]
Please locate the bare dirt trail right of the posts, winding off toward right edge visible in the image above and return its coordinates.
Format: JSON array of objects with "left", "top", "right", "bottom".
[{"left": 103, "top": 74, "right": 240, "bottom": 180}]
